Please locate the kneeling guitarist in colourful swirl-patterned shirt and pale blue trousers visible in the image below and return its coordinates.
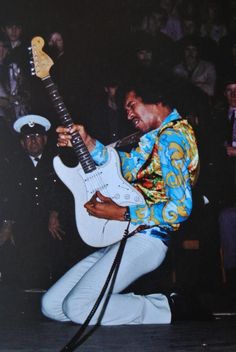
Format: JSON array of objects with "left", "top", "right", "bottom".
[{"left": 42, "top": 80, "right": 199, "bottom": 325}]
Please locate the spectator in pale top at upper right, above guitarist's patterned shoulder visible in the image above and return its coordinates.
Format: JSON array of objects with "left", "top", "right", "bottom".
[{"left": 173, "top": 37, "right": 216, "bottom": 97}]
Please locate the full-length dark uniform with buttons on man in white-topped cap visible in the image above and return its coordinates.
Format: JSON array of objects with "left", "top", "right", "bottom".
[{"left": 4, "top": 146, "right": 60, "bottom": 287}]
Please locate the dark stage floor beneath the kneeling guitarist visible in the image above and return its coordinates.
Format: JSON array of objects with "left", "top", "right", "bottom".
[{"left": 0, "top": 284, "right": 236, "bottom": 352}]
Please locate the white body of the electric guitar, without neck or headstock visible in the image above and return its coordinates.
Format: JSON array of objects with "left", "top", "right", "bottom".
[{"left": 53, "top": 147, "right": 145, "bottom": 247}]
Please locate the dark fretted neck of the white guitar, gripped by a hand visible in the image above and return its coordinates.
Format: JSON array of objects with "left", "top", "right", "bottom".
[{"left": 42, "top": 76, "right": 96, "bottom": 173}]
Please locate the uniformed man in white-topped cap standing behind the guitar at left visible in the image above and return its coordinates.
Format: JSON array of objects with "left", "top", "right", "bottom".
[{"left": 7, "top": 115, "right": 64, "bottom": 288}]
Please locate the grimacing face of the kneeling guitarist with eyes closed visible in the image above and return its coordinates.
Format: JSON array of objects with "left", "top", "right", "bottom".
[{"left": 125, "top": 90, "right": 161, "bottom": 132}]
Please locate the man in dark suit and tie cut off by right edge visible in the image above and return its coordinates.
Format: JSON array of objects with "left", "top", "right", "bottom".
[{"left": 209, "top": 75, "right": 236, "bottom": 207}]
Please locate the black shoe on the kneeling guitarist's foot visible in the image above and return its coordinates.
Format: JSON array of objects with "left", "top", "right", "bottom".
[{"left": 167, "top": 292, "right": 213, "bottom": 322}]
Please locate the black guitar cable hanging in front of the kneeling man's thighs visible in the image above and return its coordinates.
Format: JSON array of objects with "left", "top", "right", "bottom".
[{"left": 60, "top": 221, "right": 137, "bottom": 352}]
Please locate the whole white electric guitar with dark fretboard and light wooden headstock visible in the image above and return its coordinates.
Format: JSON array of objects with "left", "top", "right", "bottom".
[{"left": 31, "top": 37, "right": 145, "bottom": 247}]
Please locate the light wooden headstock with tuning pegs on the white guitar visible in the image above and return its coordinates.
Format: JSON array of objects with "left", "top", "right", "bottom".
[{"left": 30, "top": 37, "right": 53, "bottom": 79}]
